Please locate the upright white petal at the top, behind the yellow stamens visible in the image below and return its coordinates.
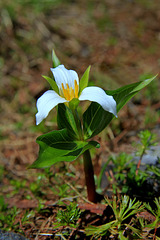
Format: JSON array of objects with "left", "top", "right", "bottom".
[{"left": 51, "top": 65, "right": 79, "bottom": 89}]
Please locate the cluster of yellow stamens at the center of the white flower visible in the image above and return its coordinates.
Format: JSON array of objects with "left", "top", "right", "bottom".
[{"left": 61, "top": 80, "right": 79, "bottom": 101}]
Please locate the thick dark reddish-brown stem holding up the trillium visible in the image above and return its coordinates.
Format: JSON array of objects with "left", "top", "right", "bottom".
[{"left": 83, "top": 150, "right": 97, "bottom": 203}]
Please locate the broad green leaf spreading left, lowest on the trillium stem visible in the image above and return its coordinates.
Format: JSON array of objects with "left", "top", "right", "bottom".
[{"left": 29, "top": 129, "right": 99, "bottom": 168}]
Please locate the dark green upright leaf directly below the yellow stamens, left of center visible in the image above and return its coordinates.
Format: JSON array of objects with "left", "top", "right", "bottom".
[{"left": 57, "top": 103, "right": 79, "bottom": 139}]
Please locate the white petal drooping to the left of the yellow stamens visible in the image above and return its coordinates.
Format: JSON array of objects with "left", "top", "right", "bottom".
[{"left": 36, "top": 90, "right": 67, "bottom": 125}]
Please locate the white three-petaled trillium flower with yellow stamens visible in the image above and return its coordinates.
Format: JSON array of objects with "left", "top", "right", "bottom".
[{"left": 36, "top": 65, "right": 117, "bottom": 125}]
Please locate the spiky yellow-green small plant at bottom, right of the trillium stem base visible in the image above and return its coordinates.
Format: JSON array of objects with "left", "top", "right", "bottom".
[{"left": 85, "top": 195, "right": 144, "bottom": 240}]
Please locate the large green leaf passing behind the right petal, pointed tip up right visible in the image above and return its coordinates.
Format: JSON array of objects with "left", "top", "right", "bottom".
[{"left": 83, "top": 76, "right": 156, "bottom": 139}]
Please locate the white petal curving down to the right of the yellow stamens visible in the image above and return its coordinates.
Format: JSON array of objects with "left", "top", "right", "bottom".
[{"left": 79, "top": 87, "right": 117, "bottom": 116}]
